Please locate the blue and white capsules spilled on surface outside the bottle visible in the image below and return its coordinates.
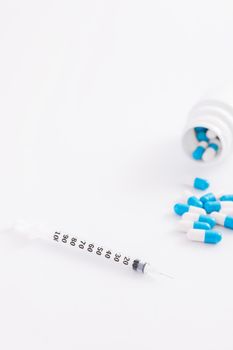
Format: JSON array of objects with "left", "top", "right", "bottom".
[{"left": 173, "top": 177, "right": 233, "bottom": 244}]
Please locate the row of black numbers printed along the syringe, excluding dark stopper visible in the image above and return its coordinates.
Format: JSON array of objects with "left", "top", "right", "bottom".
[{"left": 53, "top": 231, "right": 131, "bottom": 266}]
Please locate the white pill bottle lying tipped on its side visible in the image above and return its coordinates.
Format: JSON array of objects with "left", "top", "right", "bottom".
[{"left": 182, "top": 85, "right": 233, "bottom": 164}]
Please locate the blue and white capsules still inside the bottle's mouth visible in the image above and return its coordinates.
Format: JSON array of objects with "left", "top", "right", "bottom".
[{"left": 192, "top": 127, "right": 221, "bottom": 162}]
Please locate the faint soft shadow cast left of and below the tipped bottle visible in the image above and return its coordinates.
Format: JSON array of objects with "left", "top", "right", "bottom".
[{"left": 124, "top": 138, "right": 228, "bottom": 193}]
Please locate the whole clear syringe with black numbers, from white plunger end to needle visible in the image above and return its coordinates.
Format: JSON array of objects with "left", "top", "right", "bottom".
[{"left": 12, "top": 221, "right": 170, "bottom": 277}]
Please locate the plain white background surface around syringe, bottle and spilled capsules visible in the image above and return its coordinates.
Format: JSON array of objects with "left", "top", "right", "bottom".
[{"left": 0, "top": 0, "right": 233, "bottom": 350}]
